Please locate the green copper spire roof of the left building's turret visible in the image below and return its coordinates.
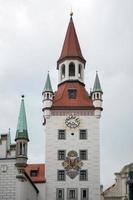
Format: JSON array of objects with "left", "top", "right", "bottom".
[{"left": 15, "top": 96, "right": 29, "bottom": 141}]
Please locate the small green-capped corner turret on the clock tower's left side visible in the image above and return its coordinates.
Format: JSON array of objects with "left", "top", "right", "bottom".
[{"left": 42, "top": 72, "right": 54, "bottom": 118}]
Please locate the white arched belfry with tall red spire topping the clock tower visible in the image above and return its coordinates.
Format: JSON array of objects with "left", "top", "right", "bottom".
[{"left": 57, "top": 14, "right": 86, "bottom": 84}]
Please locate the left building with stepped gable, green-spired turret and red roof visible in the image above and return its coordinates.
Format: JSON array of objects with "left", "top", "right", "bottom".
[{"left": 0, "top": 96, "right": 45, "bottom": 200}]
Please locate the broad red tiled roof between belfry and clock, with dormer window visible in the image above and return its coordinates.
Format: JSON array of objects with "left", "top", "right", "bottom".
[{"left": 52, "top": 82, "right": 94, "bottom": 109}]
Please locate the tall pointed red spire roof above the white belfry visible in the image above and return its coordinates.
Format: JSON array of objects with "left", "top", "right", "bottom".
[{"left": 57, "top": 12, "right": 86, "bottom": 65}]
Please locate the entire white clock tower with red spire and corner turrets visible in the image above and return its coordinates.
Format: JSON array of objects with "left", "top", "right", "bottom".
[{"left": 43, "top": 14, "right": 103, "bottom": 200}]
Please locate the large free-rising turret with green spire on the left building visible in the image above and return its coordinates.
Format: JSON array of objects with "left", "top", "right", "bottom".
[{"left": 15, "top": 95, "right": 29, "bottom": 171}]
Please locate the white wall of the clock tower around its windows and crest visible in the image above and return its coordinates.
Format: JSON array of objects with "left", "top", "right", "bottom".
[{"left": 45, "top": 111, "right": 100, "bottom": 200}]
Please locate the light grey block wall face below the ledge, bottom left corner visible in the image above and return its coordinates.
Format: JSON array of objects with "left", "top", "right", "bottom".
[{"left": 0, "top": 159, "right": 17, "bottom": 200}]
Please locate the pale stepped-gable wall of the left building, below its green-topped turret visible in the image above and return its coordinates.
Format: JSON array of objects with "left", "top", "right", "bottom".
[{"left": 0, "top": 134, "right": 42, "bottom": 200}]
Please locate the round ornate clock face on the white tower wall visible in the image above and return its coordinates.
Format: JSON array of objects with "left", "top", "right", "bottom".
[{"left": 65, "top": 114, "right": 80, "bottom": 128}]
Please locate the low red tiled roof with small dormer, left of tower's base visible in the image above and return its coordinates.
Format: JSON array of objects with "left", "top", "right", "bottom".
[{"left": 25, "top": 164, "right": 45, "bottom": 183}]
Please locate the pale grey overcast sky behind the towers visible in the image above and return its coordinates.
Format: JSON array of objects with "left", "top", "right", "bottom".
[{"left": 0, "top": 0, "right": 133, "bottom": 187}]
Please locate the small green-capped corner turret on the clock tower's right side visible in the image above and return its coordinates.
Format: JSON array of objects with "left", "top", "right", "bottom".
[{"left": 91, "top": 72, "right": 103, "bottom": 117}]
